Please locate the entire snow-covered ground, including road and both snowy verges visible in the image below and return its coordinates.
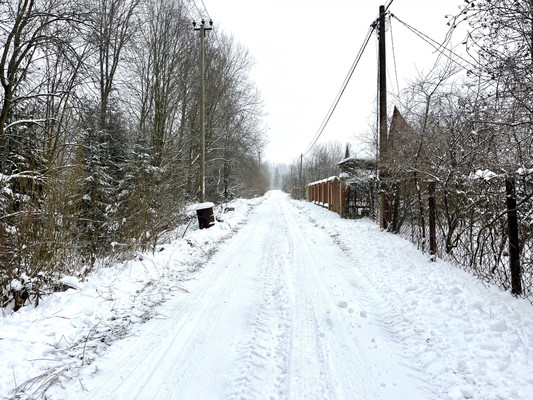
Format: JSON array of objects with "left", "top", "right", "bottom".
[{"left": 0, "top": 192, "right": 533, "bottom": 400}]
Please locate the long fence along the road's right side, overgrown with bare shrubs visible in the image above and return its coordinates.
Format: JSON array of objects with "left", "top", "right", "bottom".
[{"left": 307, "top": 174, "right": 533, "bottom": 302}]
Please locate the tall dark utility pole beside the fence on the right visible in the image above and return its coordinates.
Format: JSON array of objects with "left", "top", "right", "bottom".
[{"left": 378, "top": 6, "right": 388, "bottom": 229}]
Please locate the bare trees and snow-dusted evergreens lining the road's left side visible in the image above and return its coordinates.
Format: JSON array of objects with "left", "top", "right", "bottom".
[{"left": 0, "top": 0, "right": 268, "bottom": 308}]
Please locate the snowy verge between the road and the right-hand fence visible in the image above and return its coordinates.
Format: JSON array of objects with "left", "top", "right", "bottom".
[{"left": 295, "top": 200, "right": 533, "bottom": 400}]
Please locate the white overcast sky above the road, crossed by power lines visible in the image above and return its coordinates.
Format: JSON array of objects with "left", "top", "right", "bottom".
[{"left": 197, "top": 0, "right": 462, "bottom": 163}]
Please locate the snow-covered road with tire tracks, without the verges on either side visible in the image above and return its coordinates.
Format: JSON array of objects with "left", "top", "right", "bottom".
[{"left": 64, "top": 195, "right": 430, "bottom": 400}]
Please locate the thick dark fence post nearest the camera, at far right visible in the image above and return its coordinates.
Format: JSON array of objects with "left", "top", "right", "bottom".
[{"left": 505, "top": 177, "right": 522, "bottom": 295}]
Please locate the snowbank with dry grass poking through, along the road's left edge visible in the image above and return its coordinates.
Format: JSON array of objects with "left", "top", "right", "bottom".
[{"left": 0, "top": 198, "right": 263, "bottom": 399}]
